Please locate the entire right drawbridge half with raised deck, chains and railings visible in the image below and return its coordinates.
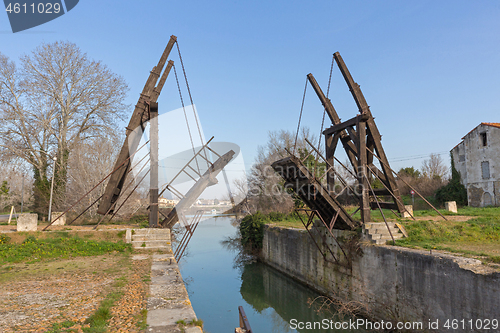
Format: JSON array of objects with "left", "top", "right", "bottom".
[{"left": 271, "top": 52, "right": 444, "bottom": 264}]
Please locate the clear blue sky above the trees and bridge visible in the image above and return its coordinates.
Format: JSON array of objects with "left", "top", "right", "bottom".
[{"left": 0, "top": 0, "right": 500, "bottom": 174}]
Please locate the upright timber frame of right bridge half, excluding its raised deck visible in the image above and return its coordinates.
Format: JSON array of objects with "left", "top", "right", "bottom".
[{"left": 307, "top": 52, "right": 405, "bottom": 223}]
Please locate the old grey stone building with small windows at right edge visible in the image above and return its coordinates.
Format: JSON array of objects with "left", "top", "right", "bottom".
[{"left": 451, "top": 123, "right": 500, "bottom": 207}]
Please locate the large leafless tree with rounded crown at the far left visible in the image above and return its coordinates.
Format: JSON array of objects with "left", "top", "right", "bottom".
[{"left": 0, "top": 42, "right": 128, "bottom": 214}]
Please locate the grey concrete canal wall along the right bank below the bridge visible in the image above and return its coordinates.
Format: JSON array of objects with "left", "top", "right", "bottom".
[{"left": 262, "top": 227, "right": 500, "bottom": 332}]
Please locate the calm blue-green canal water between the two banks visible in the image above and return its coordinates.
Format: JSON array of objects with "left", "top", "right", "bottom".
[{"left": 179, "top": 217, "right": 368, "bottom": 333}]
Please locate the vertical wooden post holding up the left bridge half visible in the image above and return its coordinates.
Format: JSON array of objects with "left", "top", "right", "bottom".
[{"left": 149, "top": 102, "right": 158, "bottom": 228}]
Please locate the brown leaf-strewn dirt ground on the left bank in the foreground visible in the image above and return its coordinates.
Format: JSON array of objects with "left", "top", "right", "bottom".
[{"left": 0, "top": 254, "right": 151, "bottom": 332}]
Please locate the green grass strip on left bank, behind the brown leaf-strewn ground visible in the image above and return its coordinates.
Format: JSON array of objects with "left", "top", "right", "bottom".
[{"left": 0, "top": 232, "right": 131, "bottom": 266}]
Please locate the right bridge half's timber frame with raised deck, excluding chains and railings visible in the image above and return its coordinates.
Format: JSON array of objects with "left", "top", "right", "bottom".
[{"left": 272, "top": 52, "right": 406, "bottom": 228}]
